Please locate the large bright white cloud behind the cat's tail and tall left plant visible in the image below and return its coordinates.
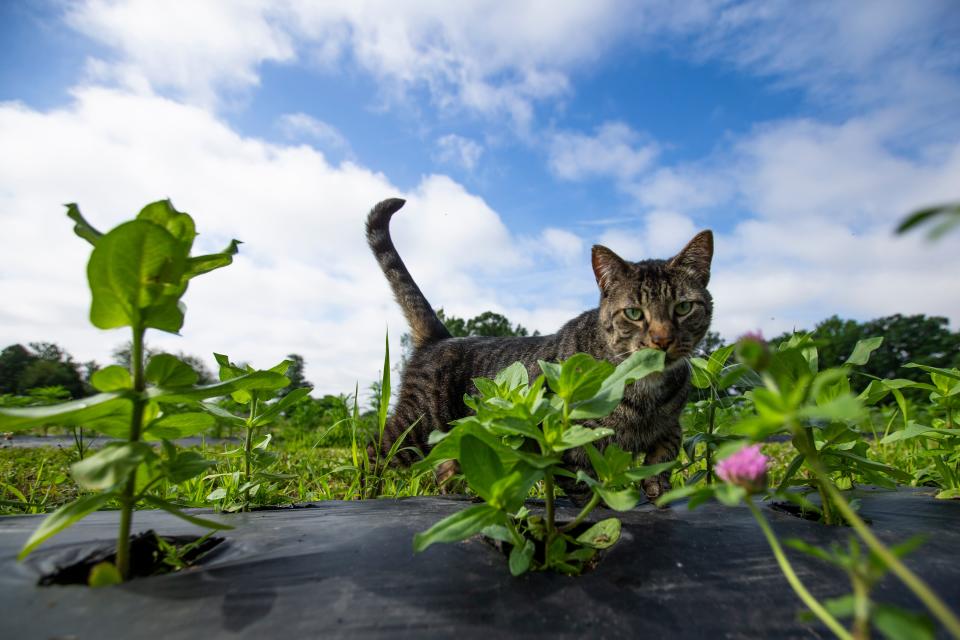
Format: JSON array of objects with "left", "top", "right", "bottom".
[{"left": 0, "top": 89, "right": 569, "bottom": 392}]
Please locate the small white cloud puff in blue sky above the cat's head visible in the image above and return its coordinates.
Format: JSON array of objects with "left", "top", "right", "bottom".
[{"left": 549, "top": 122, "right": 657, "bottom": 182}]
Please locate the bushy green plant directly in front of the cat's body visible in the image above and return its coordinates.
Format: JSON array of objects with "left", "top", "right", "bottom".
[{"left": 413, "top": 350, "right": 674, "bottom": 575}]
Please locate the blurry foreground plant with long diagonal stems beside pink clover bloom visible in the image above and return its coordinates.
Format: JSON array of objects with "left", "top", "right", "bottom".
[{"left": 658, "top": 335, "right": 960, "bottom": 638}]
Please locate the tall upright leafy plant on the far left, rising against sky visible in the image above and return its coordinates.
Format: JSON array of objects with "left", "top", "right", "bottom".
[{"left": 0, "top": 200, "right": 282, "bottom": 578}]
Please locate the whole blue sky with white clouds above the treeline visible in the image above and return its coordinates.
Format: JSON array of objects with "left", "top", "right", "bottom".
[{"left": 0, "top": 0, "right": 960, "bottom": 392}]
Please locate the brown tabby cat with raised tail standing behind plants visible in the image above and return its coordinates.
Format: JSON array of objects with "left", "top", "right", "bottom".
[{"left": 367, "top": 198, "right": 713, "bottom": 502}]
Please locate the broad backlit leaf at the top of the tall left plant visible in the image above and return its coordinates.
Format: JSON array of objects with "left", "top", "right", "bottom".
[{"left": 87, "top": 220, "right": 187, "bottom": 333}]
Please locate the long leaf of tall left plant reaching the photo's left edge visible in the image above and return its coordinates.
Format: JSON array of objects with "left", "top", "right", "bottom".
[{"left": 0, "top": 391, "right": 131, "bottom": 431}]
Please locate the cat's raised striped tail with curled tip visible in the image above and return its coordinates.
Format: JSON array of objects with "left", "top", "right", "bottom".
[{"left": 367, "top": 198, "right": 450, "bottom": 347}]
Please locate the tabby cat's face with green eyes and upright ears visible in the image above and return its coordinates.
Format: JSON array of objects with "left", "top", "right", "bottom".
[{"left": 593, "top": 231, "right": 713, "bottom": 364}]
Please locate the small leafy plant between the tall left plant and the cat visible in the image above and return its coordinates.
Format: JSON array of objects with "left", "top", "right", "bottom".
[{"left": 202, "top": 353, "right": 312, "bottom": 511}]
